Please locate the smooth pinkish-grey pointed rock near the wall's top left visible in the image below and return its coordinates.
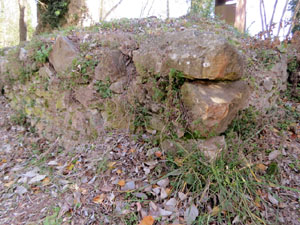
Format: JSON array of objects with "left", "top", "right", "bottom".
[{"left": 49, "top": 36, "right": 79, "bottom": 73}]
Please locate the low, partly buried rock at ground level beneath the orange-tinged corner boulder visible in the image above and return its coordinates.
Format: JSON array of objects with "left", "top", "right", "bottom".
[{"left": 161, "top": 136, "right": 226, "bottom": 162}]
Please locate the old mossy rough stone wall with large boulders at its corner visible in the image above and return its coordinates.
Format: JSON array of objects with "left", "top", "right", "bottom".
[{"left": 0, "top": 22, "right": 286, "bottom": 147}]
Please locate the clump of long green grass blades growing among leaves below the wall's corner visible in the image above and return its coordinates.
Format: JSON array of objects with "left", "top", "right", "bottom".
[{"left": 167, "top": 143, "right": 268, "bottom": 224}]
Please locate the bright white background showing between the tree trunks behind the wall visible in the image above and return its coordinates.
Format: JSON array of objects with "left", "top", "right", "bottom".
[{"left": 0, "top": 0, "right": 291, "bottom": 47}]
